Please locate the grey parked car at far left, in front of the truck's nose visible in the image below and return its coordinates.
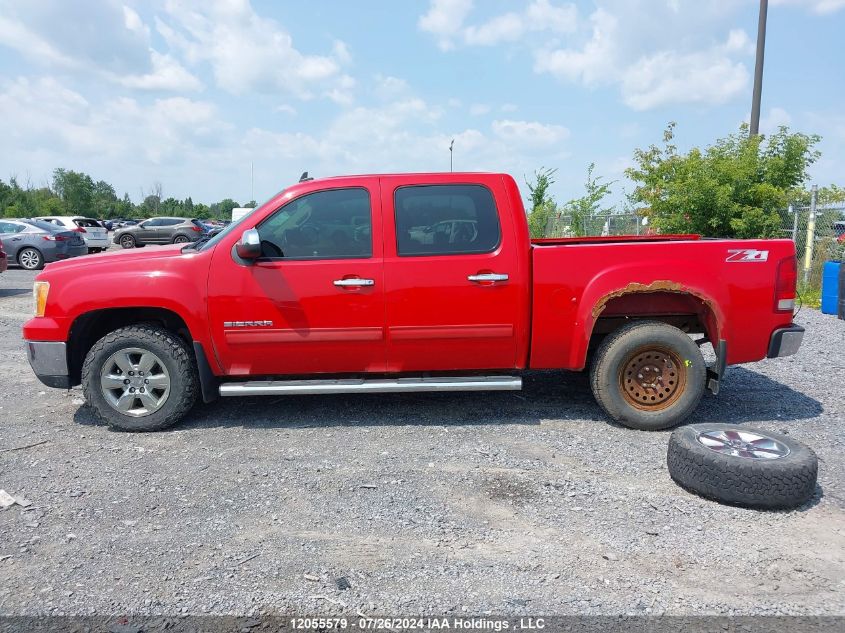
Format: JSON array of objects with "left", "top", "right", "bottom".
[{"left": 0, "top": 219, "right": 88, "bottom": 270}]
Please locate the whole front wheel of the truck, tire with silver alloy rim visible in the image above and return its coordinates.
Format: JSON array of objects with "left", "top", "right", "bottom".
[{"left": 82, "top": 325, "right": 199, "bottom": 431}]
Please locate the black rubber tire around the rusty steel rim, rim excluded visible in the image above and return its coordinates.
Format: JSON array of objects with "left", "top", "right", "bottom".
[{"left": 590, "top": 321, "right": 707, "bottom": 431}]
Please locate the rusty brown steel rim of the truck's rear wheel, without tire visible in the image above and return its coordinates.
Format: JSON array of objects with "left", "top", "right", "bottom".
[{"left": 619, "top": 346, "right": 687, "bottom": 411}]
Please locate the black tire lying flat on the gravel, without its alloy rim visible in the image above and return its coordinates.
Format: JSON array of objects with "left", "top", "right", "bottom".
[{"left": 666, "top": 424, "right": 818, "bottom": 510}]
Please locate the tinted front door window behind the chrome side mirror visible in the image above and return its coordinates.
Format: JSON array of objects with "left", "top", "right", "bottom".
[{"left": 258, "top": 188, "right": 373, "bottom": 259}]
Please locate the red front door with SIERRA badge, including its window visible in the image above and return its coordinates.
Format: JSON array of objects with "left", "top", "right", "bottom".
[{"left": 208, "top": 178, "right": 386, "bottom": 376}]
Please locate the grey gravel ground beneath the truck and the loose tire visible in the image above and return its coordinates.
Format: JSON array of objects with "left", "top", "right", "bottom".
[{"left": 0, "top": 270, "right": 845, "bottom": 615}]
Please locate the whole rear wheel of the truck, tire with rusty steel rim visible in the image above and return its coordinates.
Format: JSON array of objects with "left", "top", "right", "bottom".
[{"left": 590, "top": 321, "right": 707, "bottom": 431}]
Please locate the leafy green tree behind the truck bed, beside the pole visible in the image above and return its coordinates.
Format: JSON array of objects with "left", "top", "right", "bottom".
[{"left": 625, "top": 123, "right": 821, "bottom": 238}]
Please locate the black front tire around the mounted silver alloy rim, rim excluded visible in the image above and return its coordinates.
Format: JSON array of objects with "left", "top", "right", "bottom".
[{"left": 82, "top": 325, "right": 199, "bottom": 431}]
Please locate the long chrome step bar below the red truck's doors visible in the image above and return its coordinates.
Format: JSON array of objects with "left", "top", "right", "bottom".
[{"left": 220, "top": 376, "right": 522, "bottom": 396}]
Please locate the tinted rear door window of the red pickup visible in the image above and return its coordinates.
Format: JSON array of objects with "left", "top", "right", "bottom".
[{"left": 394, "top": 185, "right": 501, "bottom": 256}]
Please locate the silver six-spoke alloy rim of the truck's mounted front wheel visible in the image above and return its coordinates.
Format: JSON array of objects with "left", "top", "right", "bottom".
[{"left": 100, "top": 347, "right": 170, "bottom": 418}]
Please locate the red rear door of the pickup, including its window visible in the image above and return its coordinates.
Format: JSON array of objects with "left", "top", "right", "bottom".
[{"left": 382, "top": 176, "right": 524, "bottom": 372}]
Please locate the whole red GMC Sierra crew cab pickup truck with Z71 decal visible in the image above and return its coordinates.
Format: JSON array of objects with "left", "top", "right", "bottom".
[{"left": 23, "top": 173, "right": 804, "bottom": 431}]
